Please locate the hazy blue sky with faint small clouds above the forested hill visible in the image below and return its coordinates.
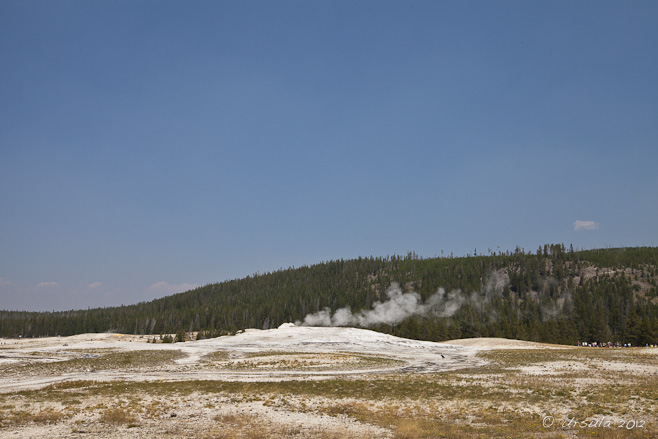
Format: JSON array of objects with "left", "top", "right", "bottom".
[{"left": 0, "top": 0, "right": 658, "bottom": 310}]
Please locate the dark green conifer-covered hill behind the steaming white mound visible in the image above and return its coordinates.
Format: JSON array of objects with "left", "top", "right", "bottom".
[{"left": 0, "top": 244, "right": 658, "bottom": 345}]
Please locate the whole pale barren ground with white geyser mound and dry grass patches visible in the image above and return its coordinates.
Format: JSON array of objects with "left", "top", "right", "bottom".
[{"left": 0, "top": 325, "right": 658, "bottom": 438}]
